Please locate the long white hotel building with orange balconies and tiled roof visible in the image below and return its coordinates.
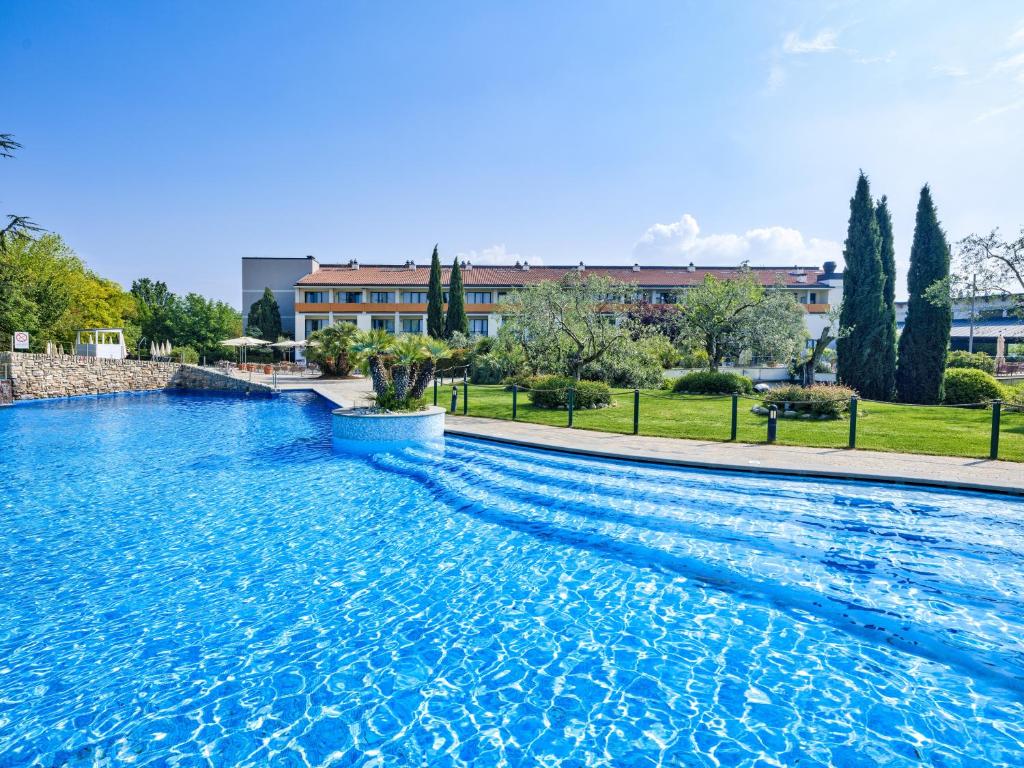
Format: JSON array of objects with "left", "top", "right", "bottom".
[{"left": 242, "top": 256, "right": 843, "bottom": 354}]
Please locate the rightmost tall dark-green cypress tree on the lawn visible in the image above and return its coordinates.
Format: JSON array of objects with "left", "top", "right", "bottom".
[{"left": 896, "top": 184, "right": 952, "bottom": 403}]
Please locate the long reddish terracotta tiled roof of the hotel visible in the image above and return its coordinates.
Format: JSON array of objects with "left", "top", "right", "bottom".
[{"left": 296, "top": 264, "right": 827, "bottom": 288}]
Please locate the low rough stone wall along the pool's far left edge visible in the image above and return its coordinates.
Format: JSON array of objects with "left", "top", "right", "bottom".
[{"left": 0, "top": 352, "right": 272, "bottom": 400}]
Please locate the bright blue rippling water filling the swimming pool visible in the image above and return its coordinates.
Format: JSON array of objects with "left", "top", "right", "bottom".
[{"left": 0, "top": 393, "right": 1024, "bottom": 768}]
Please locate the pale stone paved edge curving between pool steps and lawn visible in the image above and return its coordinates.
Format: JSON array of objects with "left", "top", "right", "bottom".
[{"left": 444, "top": 414, "right": 1024, "bottom": 497}]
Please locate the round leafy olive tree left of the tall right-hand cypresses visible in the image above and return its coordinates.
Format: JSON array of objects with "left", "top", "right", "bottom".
[{"left": 679, "top": 268, "right": 804, "bottom": 371}]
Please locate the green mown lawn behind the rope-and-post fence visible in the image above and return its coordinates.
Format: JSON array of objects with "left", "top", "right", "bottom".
[{"left": 438, "top": 385, "right": 1024, "bottom": 462}]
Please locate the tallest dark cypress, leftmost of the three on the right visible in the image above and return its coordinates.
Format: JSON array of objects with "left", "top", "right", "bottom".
[{"left": 836, "top": 171, "right": 892, "bottom": 399}]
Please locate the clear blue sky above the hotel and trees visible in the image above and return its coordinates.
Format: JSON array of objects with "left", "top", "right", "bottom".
[{"left": 0, "top": 0, "right": 1024, "bottom": 305}]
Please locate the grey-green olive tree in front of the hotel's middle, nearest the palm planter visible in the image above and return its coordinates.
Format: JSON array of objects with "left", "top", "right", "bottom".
[{"left": 501, "top": 272, "right": 634, "bottom": 381}]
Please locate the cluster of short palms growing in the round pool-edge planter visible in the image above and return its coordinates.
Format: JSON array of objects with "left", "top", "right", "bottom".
[{"left": 351, "top": 331, "right": 449, "bottom": 411}]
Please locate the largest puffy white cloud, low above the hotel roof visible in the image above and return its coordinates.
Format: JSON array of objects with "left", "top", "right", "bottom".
[{"left": 633, "top": 213, "right": 843, "bottom": 266}]
